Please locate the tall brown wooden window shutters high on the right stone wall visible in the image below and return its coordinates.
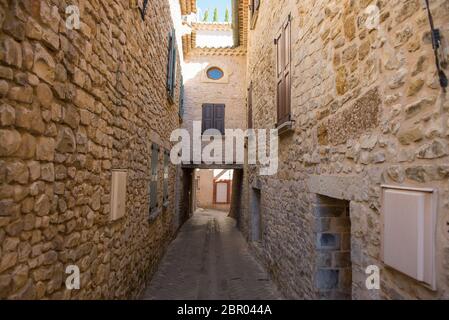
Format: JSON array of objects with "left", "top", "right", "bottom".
[{"left": 275, "top": 15, "right": 291, "bottom": 126}]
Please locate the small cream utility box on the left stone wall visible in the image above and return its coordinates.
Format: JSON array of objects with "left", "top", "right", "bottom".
[{"left": 111, "top": 170, "right": 127, "bottom": 221}]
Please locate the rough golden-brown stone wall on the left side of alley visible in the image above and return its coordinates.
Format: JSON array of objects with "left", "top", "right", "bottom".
[{"left": 0, "top": 0, "right": 180, "bottom": 299}]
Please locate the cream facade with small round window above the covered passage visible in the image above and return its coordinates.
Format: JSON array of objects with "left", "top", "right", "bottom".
[{"left": 181, "top": 0, "right": 248, "bottom": 151}]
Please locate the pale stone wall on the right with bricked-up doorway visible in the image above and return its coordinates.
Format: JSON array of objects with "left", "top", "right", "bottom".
[{"left": 241, "top": 0, "right": 449, "bottom": 299}]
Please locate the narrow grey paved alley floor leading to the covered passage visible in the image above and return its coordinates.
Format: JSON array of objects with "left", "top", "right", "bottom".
[{"left": 142, "top": 210, "right": 281, "bottom": 300}]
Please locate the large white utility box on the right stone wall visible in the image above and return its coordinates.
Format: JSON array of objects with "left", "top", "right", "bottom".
[{"left": 382, "top": 186, "right": 436, "bottom": 290}]
